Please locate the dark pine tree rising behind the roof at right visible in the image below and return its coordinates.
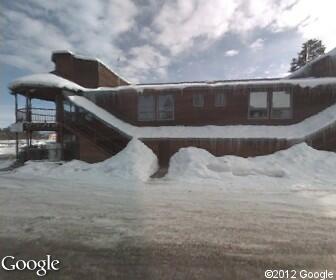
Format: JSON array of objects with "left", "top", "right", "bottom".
[{"left": 289, "top": 39, "right": 325, "bottom": 72}]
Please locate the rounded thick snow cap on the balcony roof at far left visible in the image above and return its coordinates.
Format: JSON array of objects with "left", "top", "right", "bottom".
[{"left": 9, "top": 73, "right": 85, "bottom": 91}]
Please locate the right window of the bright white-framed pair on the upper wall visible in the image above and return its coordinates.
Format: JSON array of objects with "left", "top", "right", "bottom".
[{"left": 271, "top": 91, "right": 292, "bottom": 119}]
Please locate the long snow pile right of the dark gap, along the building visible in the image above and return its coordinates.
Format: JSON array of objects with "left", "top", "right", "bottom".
[{"left": 167, "top": 143, "right": 336, "bottom": 185}]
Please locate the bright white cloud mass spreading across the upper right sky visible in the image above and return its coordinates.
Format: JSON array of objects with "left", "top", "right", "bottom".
[{"left": 149, "top": 0, "right": 336, "bottom": 56}]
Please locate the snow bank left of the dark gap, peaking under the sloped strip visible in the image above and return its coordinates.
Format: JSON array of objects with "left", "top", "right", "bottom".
[{"left": 16, "top": 139, "right": 158, "bottom": 182}]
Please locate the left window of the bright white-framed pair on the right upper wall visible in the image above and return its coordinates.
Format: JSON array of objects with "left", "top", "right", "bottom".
[{"left": 249, "top": 91, "right": 268, "bottom": 119}]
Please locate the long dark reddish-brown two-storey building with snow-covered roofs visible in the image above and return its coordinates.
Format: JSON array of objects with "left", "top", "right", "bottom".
[{"left": 10, "top": 49, "right": 336, "bottom": 166}]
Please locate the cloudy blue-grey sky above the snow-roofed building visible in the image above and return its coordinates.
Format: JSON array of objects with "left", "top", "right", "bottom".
[{"left": 0, "top": 0, "right": 336, "bottom": 127}]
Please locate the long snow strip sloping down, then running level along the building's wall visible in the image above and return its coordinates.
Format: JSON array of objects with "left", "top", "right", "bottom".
[{"left": 68, "top": 95, "right": 336, "bottom": 140}]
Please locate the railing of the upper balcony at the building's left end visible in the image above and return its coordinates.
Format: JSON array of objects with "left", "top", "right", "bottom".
[{"left": 17, "top": 108, "right": 56, "bottom": 123}]
